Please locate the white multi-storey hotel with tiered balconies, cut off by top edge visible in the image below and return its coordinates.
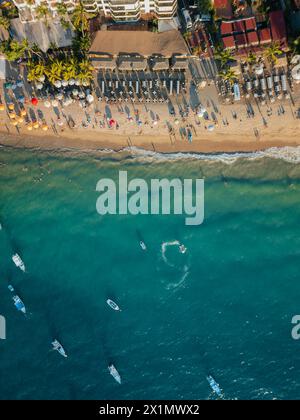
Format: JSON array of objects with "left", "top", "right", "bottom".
[{"left": 13, "top": 0, "right": 177, "bottom": 22}]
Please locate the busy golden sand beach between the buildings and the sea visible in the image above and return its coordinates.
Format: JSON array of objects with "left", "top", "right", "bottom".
[{"left": 0, "top": 72, "right": 300, "bottom": 153}]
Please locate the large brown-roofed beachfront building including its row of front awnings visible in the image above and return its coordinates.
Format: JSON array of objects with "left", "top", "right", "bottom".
[{"left": 89, "top": 30, "right": 190, "bottom": 71}]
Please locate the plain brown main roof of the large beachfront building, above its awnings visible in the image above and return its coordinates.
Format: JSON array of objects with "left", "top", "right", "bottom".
[{"left": 90, "top": 30, "right": 189, "bottom": 57}]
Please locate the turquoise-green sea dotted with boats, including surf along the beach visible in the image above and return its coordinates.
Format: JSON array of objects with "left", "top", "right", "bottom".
[{"left": 0, "top": 148, "right": 300, "bottom": 399}]
